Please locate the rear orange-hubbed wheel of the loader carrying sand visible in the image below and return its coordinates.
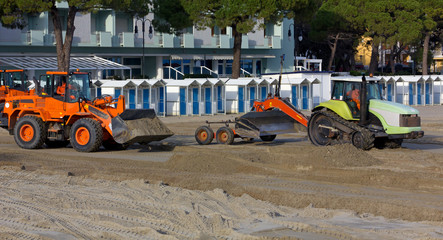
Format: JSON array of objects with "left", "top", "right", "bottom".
[{"left": 14, "top": 115, "right": 46, "bottom": 149}]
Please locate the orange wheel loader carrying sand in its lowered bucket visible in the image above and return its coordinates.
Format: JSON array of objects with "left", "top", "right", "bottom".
[{"left": 4, "top": 71, "right": 173, "bottom": 152}]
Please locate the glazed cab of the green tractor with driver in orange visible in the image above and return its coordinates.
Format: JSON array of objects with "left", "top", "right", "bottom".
[{"left": 332, "top": 81, "right": 383, "bottom": 118}]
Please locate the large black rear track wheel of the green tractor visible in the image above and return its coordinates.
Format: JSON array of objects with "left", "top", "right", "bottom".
[{"left": 308, "top": 112, "right": 333, "bottom": 146}]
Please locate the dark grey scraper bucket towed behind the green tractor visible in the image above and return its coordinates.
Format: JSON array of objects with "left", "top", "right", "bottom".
[{"left": 235, "top": 110, "right": 304, "bottom": 138}]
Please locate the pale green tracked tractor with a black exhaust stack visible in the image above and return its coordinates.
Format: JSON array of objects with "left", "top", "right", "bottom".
[{"left": 308, "top": 76, "right": 423, "bottom": 150}]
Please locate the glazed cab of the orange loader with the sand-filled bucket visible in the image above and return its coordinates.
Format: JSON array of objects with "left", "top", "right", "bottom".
[{"left": 38, "top": 71, "right": 90, "bottom": 103}]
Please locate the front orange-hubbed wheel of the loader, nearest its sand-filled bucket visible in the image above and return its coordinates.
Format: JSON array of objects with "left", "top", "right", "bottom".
[{"left": 71, "top": 118, "right": 103, "bottom": 152}]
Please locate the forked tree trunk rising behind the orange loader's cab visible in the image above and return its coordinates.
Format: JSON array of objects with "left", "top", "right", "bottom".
[{"left": 51, "top": 4, "right": 77, "bottom": 72}]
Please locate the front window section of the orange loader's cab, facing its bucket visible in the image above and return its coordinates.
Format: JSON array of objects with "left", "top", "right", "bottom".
[{"left": 67, "top": 73, "right": 91, "bottom": 102}]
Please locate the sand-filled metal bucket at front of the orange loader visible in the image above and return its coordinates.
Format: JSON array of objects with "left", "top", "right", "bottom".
[{"left": 111, "top": 109, "right": 174, "bottom": 144}]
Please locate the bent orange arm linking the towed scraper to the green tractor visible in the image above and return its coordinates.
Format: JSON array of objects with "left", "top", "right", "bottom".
[{"left": 253, "top": 97, "right": 308, "bottom": 127}]
